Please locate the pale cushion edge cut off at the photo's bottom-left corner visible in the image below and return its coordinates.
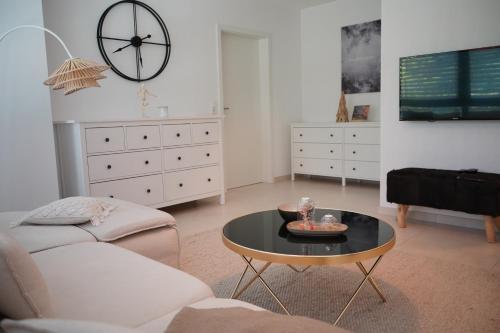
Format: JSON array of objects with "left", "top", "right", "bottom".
[{"left": 0, "top": 319, "right": 141, "bottom": 333}]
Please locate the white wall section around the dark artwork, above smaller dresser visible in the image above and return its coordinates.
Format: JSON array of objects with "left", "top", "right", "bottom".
[{"left": 301, "top": 0, "right": 384, "bottom": 121}]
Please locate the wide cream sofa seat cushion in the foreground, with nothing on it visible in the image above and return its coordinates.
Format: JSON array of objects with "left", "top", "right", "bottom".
[{"left": 32, "top": 243, "right": 213, "bottom": 327}]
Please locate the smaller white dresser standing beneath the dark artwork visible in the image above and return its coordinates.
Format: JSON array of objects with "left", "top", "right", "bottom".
[{"left": 291, "top": 122, "right": 380, "bottom": 186}]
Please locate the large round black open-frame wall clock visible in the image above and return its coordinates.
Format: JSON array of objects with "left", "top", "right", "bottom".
[{"left": 97, "top": 0, "right": 171, "bottom": 82}]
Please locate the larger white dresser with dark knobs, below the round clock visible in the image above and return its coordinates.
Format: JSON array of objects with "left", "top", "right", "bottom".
[{"left": 55, "top": 117, "right": 225, "bottom": 208}]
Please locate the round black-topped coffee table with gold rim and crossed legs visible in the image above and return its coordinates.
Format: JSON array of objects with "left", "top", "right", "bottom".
[{"left": 222, "top": 209, "right": 396, "bottom": 325}]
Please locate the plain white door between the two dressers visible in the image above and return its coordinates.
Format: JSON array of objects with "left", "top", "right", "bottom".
[{"left": 222, "top": 32, "right": 263, "bottom": 188}]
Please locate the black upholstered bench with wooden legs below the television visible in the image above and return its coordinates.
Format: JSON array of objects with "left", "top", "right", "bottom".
[{"left": 387, "top": 168, "right": 500, "bottom": 243}]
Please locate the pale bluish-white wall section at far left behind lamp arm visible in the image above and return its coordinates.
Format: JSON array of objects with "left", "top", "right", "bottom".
[{"left": 0, "top": 0, "right": 59, "bottom": 211}]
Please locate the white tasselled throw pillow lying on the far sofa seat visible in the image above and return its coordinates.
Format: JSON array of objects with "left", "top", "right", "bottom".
[{"left": 23, "top": 197, "right": 116, "bottom": 225}]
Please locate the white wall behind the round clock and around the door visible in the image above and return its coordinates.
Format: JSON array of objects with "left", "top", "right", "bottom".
[{"left": 43, "top": 0, "right": 301, "bottom": 176}]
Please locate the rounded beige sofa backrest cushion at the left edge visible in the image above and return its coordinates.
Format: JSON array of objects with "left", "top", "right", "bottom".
[{"left": 0, "top": 233, "right": 53, "bottom": 319}]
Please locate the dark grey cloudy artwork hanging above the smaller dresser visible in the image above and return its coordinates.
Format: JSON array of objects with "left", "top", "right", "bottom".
[{"left": 341, "top": 20, "right": 382, "bottom": 94}]
